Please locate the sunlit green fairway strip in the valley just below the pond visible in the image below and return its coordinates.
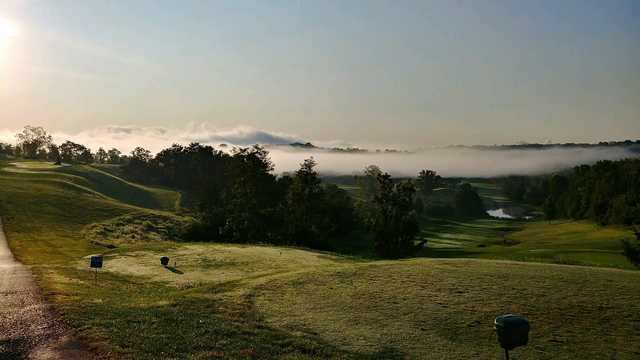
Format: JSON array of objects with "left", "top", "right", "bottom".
[{"left": 421, "top": 219, "right": 634, "bottom": 269}]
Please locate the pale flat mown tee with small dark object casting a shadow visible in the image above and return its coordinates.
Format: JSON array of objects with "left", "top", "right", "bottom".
[{"left": 98, "top": 244, "right": 349, "bottom": 287}]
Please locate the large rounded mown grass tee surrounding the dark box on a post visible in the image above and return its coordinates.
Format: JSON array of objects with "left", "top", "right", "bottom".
[{"left": 256, "top": 259, "right": 640, "bottom": 359}]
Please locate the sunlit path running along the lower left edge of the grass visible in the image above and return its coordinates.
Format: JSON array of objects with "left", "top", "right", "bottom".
[{"left": 0, "top": 220, "right": 95, "bottom": 360}]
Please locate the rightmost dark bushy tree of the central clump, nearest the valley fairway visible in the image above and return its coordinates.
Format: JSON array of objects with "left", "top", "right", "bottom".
[{"left": 369, "top": 174, "right": 420, "bottom": 258}]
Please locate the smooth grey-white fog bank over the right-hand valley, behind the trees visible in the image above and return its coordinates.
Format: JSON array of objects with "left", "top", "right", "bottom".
[{"left": 270, "top": 147, "right": 639, "bottom": 177}]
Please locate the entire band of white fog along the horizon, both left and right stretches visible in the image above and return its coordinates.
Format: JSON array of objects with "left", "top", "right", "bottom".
[{"left": 0, "top": 124, "right": 640, "bottom": 177}]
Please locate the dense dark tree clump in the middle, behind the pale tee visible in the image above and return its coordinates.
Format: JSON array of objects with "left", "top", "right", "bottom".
[{"left": 123, "top": 143, "right": 430, "bottom": 258}]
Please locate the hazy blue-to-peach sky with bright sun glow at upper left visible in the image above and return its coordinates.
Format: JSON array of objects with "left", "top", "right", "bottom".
[{"left": 0, "top": 0, "right": 640, "bottom": 147}]
